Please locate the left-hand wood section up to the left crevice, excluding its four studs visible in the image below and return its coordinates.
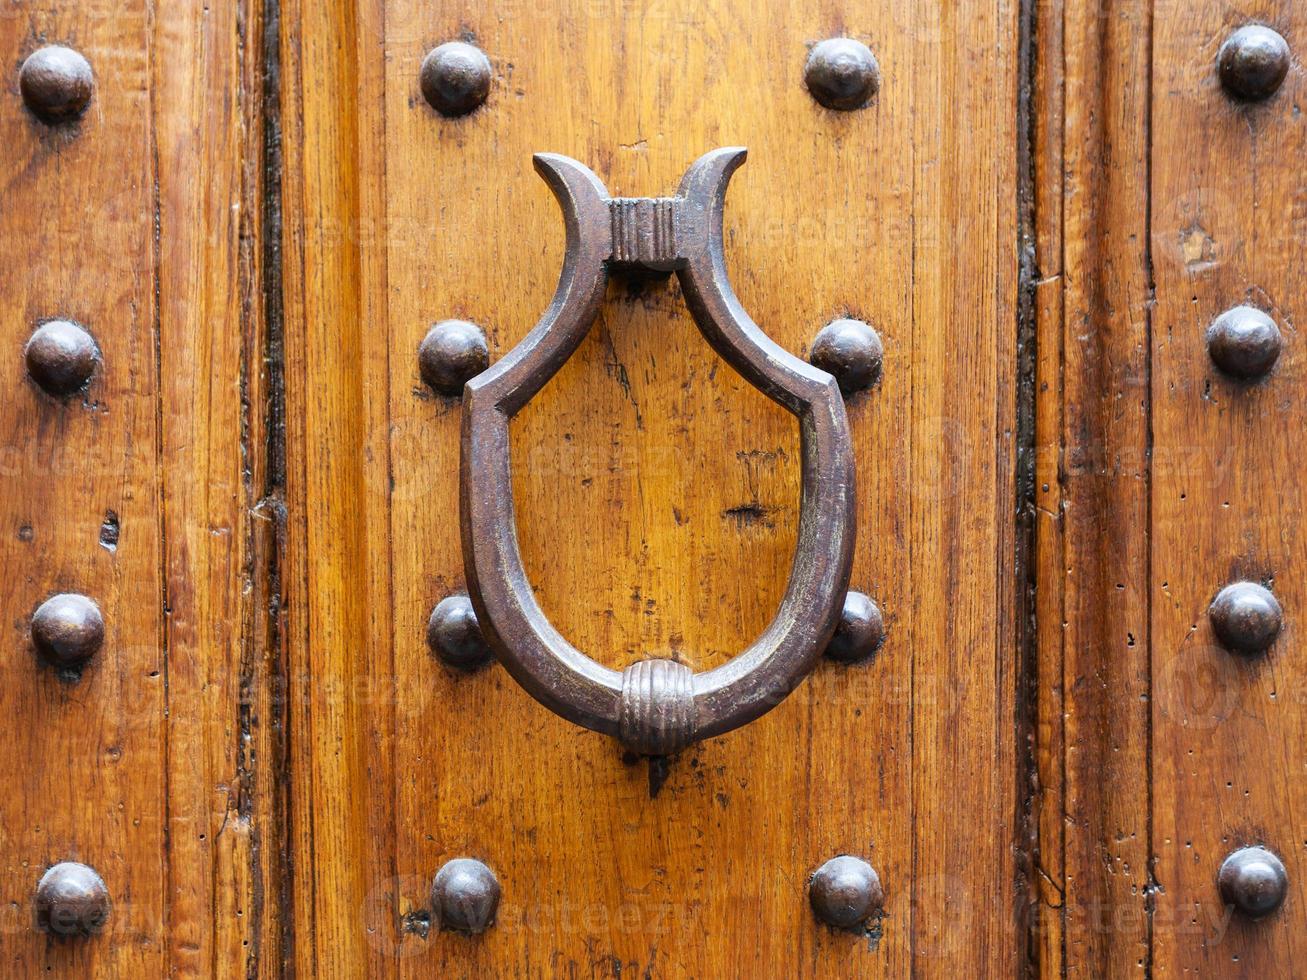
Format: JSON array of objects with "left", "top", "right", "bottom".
[{"left": 0, "top": 3, "right": 281, "bottom": 977}]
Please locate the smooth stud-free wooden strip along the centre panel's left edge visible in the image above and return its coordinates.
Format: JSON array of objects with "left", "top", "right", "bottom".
[{"left": 281, "top": 1, "right": 396, "bottom": 976}]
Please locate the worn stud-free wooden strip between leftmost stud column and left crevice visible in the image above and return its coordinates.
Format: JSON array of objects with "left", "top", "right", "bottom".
[{"left": 151, "top": 3, "right": 282, "bottom": 977}]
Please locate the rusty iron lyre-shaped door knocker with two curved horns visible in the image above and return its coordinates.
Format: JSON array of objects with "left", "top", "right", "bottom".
[{"left": 460, "top": 148, "right": 853, "bottom": 755}]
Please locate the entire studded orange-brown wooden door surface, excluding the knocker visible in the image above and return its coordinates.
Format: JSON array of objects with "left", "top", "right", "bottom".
[{"left": 0, "top": 0, "right": 1307, "bottom": 977}]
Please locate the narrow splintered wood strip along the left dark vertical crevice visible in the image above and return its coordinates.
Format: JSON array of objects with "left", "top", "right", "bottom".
[{"left": 235, "top": 0, "right": 294, "bottom": 977}]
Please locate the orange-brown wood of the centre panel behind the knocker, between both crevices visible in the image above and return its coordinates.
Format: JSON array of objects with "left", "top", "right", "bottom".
[{"left": 282, "top": 1, "right": 1023, "bottom": 976}]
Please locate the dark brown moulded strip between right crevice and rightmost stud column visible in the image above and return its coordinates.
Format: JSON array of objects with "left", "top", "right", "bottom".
[{"left": 1035, "top": 0, "right": 1151, "bottom": 976}]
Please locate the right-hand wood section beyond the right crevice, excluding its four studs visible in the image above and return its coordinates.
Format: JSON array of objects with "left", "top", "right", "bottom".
[{"left": 1031, "top": 0, "right": 1307, "bottom": 976}]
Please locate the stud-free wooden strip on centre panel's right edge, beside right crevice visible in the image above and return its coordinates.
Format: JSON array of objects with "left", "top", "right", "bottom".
[{"left": 910, "top": 3, "right": 1026, "bottom": 975}]
